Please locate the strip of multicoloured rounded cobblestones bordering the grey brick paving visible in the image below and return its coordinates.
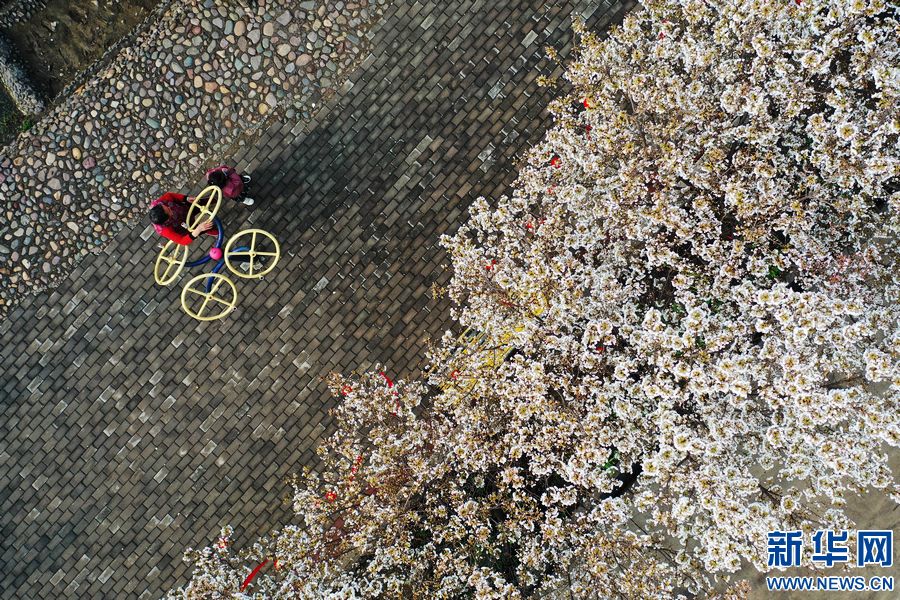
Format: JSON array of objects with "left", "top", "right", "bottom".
[{"left": 0, "top": 0, "right": 387, "bottom": 316}]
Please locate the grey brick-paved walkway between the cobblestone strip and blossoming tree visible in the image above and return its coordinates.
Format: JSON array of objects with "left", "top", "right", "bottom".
[{"left": 0, "top": 0, "right": 621, "bottom": 600}]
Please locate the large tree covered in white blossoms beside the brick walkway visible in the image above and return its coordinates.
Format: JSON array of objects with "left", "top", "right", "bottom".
[{"left": 167, "top": 0, "right": 900, "bottom": 598}]
